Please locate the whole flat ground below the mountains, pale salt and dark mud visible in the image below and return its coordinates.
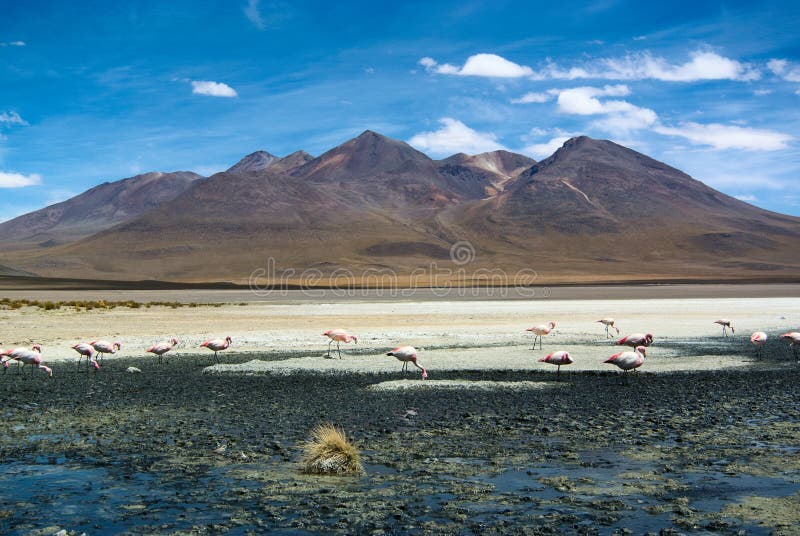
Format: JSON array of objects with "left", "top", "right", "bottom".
[{"left": 0, "top": 285, "right": 800, "bottom": 534}]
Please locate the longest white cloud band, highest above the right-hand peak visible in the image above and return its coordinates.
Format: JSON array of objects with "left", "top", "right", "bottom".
[{"left": 419, "top": 50, "right": 761, "bottom": 82}]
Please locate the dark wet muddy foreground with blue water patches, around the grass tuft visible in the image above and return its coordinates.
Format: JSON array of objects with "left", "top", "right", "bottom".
[{"left": 0, "top": 355, "right": 800, "bottom": 534}]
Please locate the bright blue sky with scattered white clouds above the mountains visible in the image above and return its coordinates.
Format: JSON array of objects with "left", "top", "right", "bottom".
[{"left": 0, "top": 0, "right": 800, "bottom": 219}]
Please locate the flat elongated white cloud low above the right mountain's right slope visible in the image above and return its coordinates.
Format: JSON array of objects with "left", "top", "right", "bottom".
[{"left": 654, "top": 122, "right": 793, "bottom": 151}]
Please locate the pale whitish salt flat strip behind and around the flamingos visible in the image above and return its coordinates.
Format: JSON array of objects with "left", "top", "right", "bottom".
[{"left": 0, "top": 285, "right": 800, "bottom": 372}]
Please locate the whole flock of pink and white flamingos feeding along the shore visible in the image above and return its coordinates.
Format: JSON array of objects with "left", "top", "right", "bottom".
[{"left": 0, "top": 318, "right": 800, "bottom": 380}]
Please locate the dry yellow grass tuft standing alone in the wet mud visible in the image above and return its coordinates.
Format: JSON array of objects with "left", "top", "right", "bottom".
[{"left": 302, "top": 424, "right": 364, "bottom": 475}]
